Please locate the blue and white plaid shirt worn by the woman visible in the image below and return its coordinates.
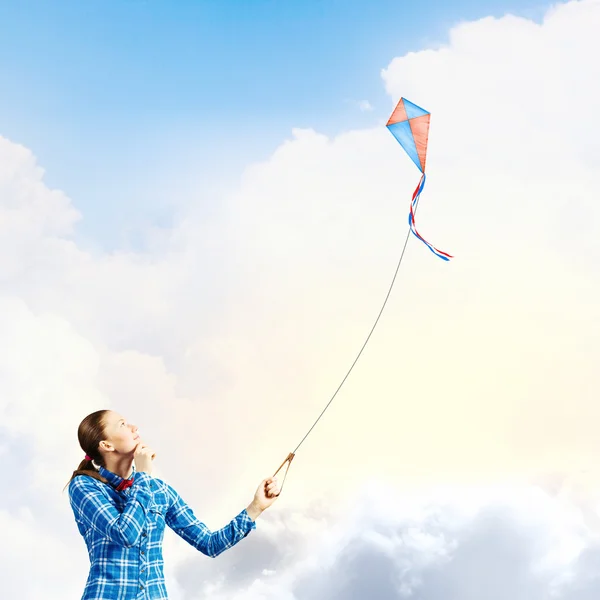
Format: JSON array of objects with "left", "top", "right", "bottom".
[{"left": 69, "top": 467, "right": 256, "bottom": 600}]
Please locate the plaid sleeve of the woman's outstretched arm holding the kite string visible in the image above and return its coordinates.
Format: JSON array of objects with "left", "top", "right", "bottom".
[{"left": 165, "top": 484, "right": 256, "bottom": 558}]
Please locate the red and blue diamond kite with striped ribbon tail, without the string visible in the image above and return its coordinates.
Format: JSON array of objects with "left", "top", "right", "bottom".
[{"left": 386, "top": 98, "right": 453, "bottom": 260}]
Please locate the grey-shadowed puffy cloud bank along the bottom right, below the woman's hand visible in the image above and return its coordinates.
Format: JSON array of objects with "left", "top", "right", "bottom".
[{"left": 170, "top": 479, "right": 599, "bottom": 600}]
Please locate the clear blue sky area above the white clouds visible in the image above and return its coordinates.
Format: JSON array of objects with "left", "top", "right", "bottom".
[{"left": 0, "top": 0, "right": 547, "bottom": 250}]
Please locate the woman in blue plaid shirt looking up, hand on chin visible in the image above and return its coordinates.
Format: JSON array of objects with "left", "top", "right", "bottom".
[{"left": 65, "top": 410, "right": 279, "bottom": 600}]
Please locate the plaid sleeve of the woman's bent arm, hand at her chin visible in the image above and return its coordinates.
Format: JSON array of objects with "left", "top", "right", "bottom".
[{"left": 69, "top": 472, "right": 152, "bottom": 548}]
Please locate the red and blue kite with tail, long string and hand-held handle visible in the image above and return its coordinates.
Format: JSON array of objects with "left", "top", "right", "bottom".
[{"left": 273, "top": 98, "right": 453, "bottom": 494}]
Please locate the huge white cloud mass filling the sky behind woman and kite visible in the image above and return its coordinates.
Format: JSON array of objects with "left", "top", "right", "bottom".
[{"left": 0, "top": 1, "right": 600, "bottom": 600}]
